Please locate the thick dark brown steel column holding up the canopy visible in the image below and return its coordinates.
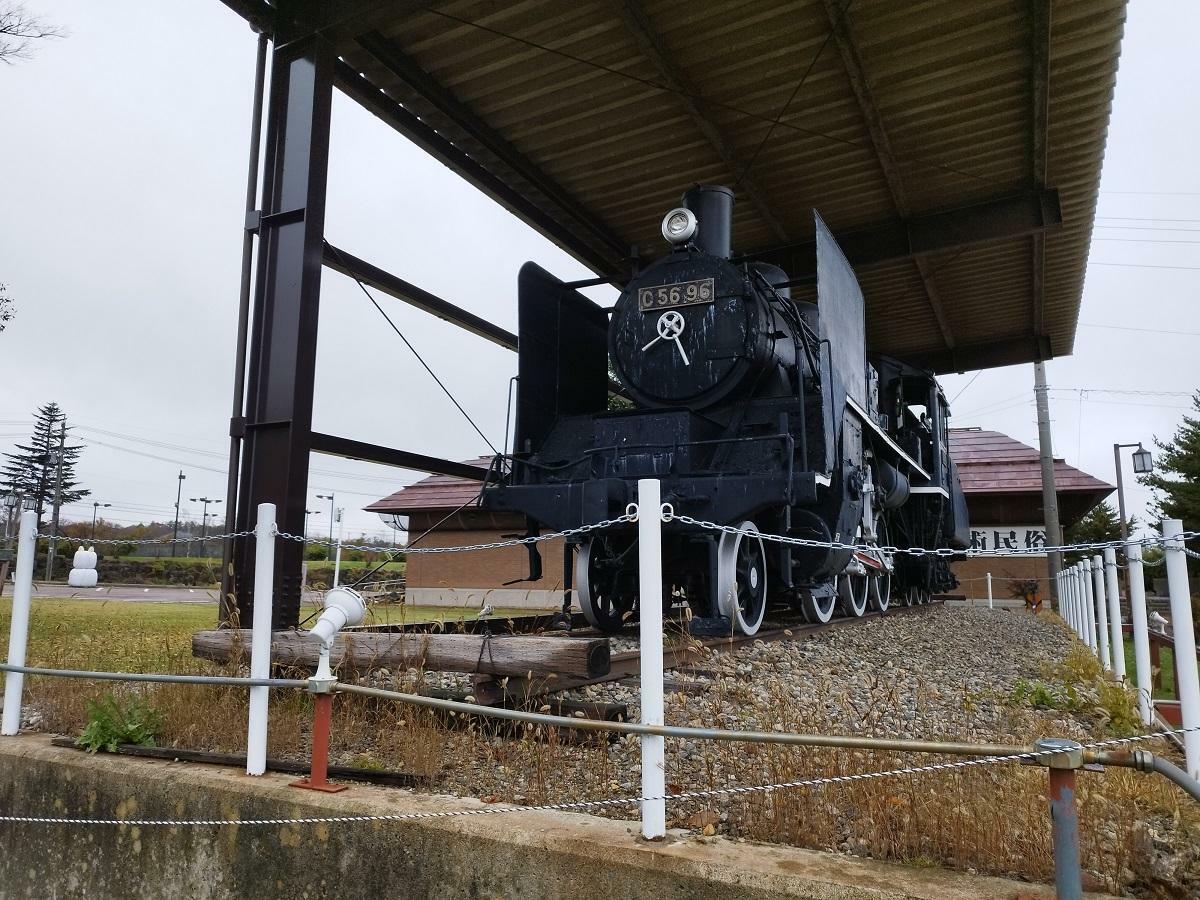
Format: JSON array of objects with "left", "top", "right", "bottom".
[{"left": 234, "top": 35, "right": 336, "bottom": 629}]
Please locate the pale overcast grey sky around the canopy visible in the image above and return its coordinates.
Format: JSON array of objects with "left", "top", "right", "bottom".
[{"left": 0, "top": 0, "right": 1200, "bottom": 542}]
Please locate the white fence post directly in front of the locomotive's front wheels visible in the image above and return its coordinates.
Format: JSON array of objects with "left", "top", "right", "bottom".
[{"left": 637, "top": 478, "right": 667, "bottom": 840}]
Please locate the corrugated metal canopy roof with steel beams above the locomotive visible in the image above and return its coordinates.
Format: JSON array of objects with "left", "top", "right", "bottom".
[{"left": 224, "top": 0, "right": 1126, "bottom": 372}]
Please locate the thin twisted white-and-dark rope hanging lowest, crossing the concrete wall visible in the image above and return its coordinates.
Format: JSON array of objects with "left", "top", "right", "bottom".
[{"left": 0, "top": 726, "right": 1200, "bottom": 828}]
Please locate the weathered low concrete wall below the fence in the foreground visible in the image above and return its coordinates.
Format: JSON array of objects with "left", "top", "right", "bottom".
[{"left": 0, "top": 736, "right": 1113, "bottom": 900}]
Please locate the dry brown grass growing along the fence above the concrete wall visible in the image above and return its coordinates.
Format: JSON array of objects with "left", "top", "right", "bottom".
[{"left": 9, "top": 607, "right": 1200, "bottom": 898}]
